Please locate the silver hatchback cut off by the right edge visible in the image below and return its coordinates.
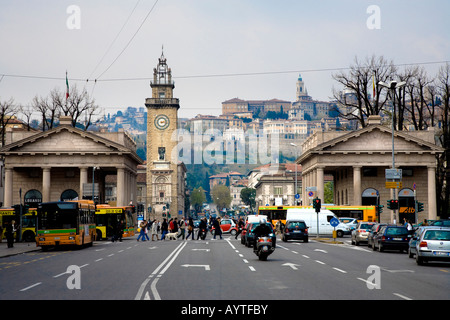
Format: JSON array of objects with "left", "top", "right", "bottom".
[{"left": 416, "top": 227, "right": 450, "bottom": 265}]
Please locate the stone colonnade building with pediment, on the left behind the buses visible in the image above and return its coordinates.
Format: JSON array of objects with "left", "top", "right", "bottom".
[{"left": 0, "top": 116, "right": 142, "bottom": 207}]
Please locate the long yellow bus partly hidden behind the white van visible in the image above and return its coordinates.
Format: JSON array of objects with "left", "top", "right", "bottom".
[{"left": 258, "top": 204, "right": 378, "bottom": 226}]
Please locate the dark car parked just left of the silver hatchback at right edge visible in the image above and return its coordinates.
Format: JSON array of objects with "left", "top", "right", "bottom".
[{"left": 372, "top": 225, "right": 409, "bottom": 252}]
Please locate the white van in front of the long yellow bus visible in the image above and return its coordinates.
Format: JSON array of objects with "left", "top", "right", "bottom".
[{"left": 286, "top": 208, "right": 350, "bottom": 237}]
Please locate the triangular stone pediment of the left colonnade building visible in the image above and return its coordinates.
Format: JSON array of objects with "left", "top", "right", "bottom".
[{"left": 0, "top": 126, "right": 129, "bottom": 153}]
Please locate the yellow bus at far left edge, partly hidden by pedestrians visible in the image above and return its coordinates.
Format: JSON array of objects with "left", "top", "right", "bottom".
[{"left": 0, "top": 206, "right": 36, "bottom": 242}]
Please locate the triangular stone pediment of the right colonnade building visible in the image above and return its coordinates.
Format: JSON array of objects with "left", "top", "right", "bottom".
[{"left": 315, "top": 125, "right": 441, "bottom": 152}]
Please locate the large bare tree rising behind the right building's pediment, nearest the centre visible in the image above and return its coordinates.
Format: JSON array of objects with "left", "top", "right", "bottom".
[{"left": 333, "top": 56, "right": 396, "bottom": 127}]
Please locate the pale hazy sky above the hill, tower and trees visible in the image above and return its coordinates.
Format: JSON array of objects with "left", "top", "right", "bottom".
[{"left": 0, "top": 0, "right": 450, "bottom": 117}]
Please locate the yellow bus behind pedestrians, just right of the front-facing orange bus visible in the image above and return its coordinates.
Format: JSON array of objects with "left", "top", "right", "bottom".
[{"left": 95, "top": 204, "right": 135, "bottom": 240}]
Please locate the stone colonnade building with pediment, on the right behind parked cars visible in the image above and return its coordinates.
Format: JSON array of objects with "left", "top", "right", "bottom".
[{"left": 297, "top": 116, "right": 443, "bottom": 223}]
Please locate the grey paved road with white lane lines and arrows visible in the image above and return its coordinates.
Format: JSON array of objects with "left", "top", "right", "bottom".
[{"left": 0, "top": 236, "right": 450, "bottom": 303}]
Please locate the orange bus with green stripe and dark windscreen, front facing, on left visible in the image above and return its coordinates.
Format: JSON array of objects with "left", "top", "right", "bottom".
[{"left": 36, "top": 200, "right": 95, "bottom": 251}]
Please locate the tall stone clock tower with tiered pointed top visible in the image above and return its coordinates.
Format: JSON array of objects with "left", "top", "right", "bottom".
[{"left": 145, "top": 53, "right": 184, "bottom": 222}]
